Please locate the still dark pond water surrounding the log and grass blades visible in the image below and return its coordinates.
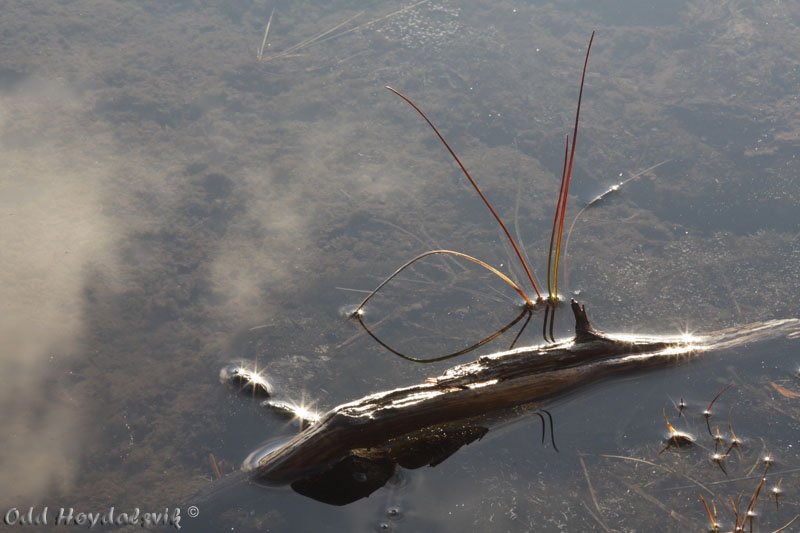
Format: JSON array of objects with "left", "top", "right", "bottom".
[{"left": 0, "top": 0, "right": 800, "bottom": 531}]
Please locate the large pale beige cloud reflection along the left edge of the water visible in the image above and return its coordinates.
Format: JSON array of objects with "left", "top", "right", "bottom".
[{"left": 0, "top": 80, "right": 121, "bottom": 504}]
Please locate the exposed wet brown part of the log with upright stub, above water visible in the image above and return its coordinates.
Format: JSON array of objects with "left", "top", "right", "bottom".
[{"left": 253, "top": 301, "right": 693, "bottom": 483}]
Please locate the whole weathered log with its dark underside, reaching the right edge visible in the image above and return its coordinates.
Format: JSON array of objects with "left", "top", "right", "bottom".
[{"left": 246, "top": 301, "right": 800, "bottom": 505}]
